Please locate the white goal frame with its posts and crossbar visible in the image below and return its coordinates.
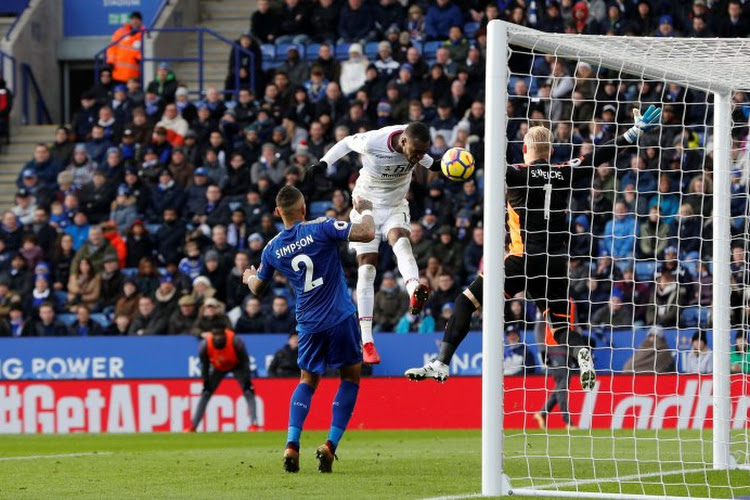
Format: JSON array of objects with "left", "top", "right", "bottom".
[{"left": 481, "top": 20, "right": 750, "bottom": 498}]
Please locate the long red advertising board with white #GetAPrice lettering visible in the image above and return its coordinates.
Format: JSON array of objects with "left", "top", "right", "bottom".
[{"left": 0, "top": 375, "right": 750, "bottom": 434}]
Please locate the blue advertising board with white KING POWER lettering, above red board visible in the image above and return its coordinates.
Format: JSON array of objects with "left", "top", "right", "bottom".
[{"left": 0, "top": 328, "right": 732, "bottom": 380}]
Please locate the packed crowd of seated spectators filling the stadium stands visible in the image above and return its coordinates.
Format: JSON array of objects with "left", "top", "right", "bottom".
[{"left": 0, "top": 0, "right": 750, "bottom": 372}]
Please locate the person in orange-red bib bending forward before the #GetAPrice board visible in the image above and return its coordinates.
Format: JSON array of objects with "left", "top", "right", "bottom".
[{"left": 185, "top": 328, "right": 259, "bottom": 432}]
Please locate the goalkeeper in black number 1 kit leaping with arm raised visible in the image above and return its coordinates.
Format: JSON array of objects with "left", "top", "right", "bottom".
[{"left": 405, "top": 106, "right": 661, "bottom": 389}]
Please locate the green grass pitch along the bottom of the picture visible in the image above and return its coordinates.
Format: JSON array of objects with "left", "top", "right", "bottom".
[{"left": 0, "top": 431, "right": 750, "bottom": 499}]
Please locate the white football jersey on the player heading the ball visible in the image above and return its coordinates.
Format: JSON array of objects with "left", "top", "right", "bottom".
[{"left": 321, "top": 125, "right": 432, "bottom": 205}]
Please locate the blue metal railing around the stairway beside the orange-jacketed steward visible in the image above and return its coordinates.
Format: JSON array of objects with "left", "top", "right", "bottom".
[{"left": 94, "top": 28, "right": 256, "bottom": 100}]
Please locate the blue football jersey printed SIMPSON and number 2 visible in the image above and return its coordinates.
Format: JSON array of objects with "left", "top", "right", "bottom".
[{"left": 258, "top": 218, "right": 355, "bottom": 333}]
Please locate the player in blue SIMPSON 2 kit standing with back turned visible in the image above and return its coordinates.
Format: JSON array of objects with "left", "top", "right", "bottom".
[{"left": 242, "top": 186, "right": 375, "bottom": 472}]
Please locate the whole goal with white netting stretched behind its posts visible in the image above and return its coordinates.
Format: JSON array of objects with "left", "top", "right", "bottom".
[{"left": 482, "top": 21, "right": 750, "bottom": 498}]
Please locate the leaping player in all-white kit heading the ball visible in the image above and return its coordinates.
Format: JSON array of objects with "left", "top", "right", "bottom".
[{"left": 310, "top": 122, "right": 440, "bottom": 364}]
